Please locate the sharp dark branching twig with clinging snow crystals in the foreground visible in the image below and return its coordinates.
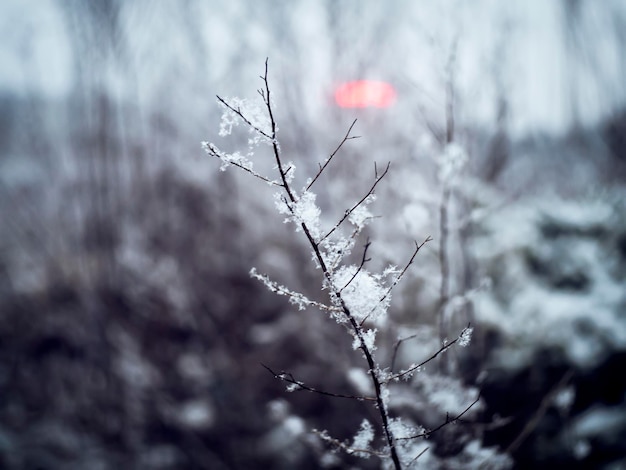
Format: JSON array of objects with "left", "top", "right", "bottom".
[{"left": 202, "top": 61, "right": 504, "bottom": 470}]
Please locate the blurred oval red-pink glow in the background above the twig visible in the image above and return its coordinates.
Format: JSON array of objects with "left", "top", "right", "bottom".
[{"left": 335, "top": 80, "right": 396, "bottom": 108}]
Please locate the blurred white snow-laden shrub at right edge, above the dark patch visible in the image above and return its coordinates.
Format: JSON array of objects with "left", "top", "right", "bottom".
[{"left": 476, "top": 197, "right": 626, "bottom": 369}]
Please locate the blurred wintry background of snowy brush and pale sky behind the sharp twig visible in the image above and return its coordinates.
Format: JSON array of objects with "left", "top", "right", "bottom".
[{"left": 0, "top": 0, "right": 626, "bottom": 470}]
